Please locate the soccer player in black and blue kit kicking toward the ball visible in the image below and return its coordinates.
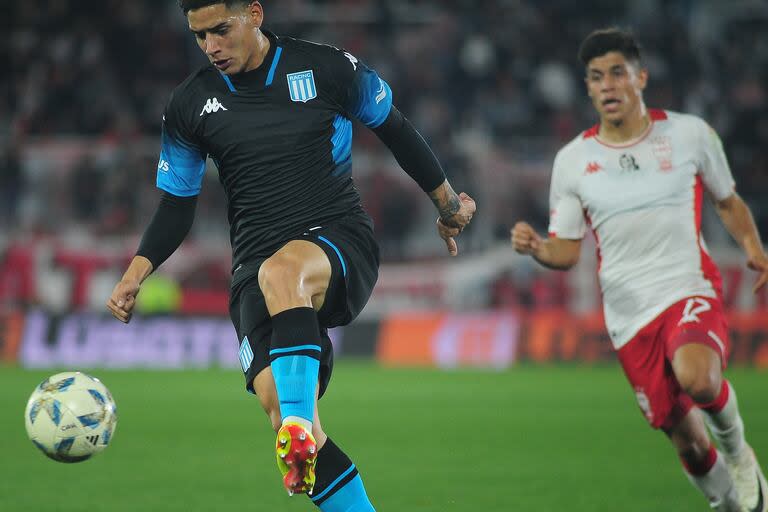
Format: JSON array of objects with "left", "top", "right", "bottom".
[{"left": 107, "top": 0, "right": 475, "bottom": 512}]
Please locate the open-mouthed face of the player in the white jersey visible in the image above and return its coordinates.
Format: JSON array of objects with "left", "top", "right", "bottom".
[{"left": 584, "top": 52, "right": 648, "bottom": 124}]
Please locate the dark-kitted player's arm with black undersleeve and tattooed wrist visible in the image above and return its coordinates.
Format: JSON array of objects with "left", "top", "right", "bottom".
[{"left": 373, "top": 105, "right": 477, "bottom": 256}]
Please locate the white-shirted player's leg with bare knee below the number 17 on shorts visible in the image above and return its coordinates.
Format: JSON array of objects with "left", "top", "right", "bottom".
[{"left": 672, "top": 344, "right": 768, "bottom": 512}]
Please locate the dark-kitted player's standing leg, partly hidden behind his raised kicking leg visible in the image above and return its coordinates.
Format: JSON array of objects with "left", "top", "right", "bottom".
[{"left": 253, "top": 367, "right": 375, "bottom": 512}]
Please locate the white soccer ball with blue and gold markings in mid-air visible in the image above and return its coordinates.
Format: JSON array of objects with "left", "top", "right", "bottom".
[{"left": 24, "top": 372, "right": 117, "bottom": 462}]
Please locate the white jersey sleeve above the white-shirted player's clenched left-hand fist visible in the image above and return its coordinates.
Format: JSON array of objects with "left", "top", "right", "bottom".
[{"left": 549, "top": 153, "right": 587, "bottom": 240}]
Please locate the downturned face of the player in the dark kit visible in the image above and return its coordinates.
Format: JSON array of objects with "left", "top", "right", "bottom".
[{"left": 187, "top": 2, "right": 264, "bottom": 75}]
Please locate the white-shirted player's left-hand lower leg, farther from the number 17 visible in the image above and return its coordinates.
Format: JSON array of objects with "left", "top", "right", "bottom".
[{"left": 666, "top": 408, "right": 742, "bottom": 512}]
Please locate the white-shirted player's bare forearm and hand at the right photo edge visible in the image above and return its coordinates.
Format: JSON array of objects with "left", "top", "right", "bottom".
[{"left": 715, "top": 193, "right": 768, "bottom": 293}]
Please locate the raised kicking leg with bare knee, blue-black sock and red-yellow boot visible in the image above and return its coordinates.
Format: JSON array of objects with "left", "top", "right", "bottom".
[{"left": 259, "top": 240, "right": 331, "bottom": 493}]
